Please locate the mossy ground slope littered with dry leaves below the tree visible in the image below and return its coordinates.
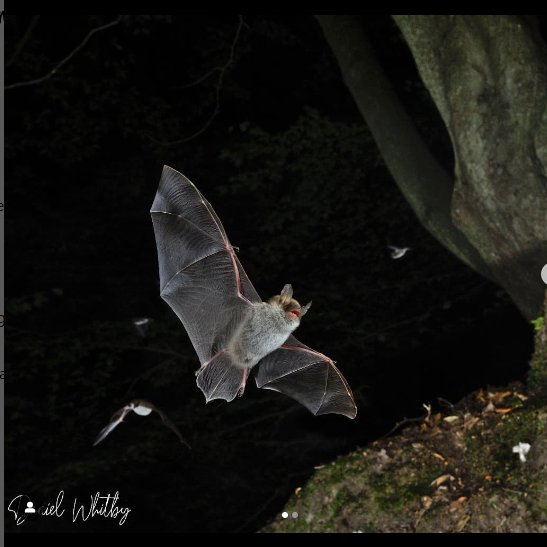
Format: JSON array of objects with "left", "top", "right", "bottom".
[{"left": 264, "top": 385, "right": 547, "bottom": 533}]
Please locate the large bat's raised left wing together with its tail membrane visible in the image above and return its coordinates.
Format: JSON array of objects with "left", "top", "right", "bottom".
[{"left": 151, "top": 166, "right": 261, "bottom": 401}]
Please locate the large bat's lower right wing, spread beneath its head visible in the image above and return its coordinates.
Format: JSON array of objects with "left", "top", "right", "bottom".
[{"left": 255, "top": 336, "right": 357, "bottom": 419}]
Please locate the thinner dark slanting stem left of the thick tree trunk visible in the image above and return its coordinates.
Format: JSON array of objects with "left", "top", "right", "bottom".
[{"left": 316, "top": 15, "right": 492, "bottom": 278}]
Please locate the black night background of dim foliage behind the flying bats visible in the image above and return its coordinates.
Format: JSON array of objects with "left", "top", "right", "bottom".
[{"left": 5, "top": 15, "right": 532, "bottom": 532}]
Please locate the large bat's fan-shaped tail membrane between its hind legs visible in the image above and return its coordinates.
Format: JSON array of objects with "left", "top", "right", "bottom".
[{"left": 196, "top": 351, "right": 247, "bottom": 402}]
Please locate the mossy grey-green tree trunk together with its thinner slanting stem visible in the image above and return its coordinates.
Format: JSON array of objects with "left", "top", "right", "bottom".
[{"left": 317, "top": 15, "right": 547, "bottom": 318}]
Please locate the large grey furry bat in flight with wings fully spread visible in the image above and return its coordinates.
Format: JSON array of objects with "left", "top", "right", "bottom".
[{"left": 151, "top": 166, "right": 357, "bottom": 418}]
